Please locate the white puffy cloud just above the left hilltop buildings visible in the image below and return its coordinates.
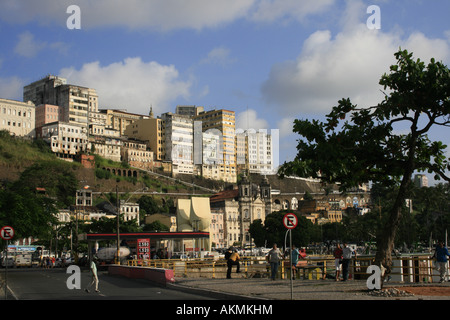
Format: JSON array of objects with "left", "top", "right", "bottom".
[{"left": 60, "top": 57, "right": 191, "bottom": 114}]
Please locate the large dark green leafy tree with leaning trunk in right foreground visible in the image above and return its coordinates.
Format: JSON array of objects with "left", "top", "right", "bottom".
[{"left": 279, "top": 50, "right": 450, "bottom": 279}]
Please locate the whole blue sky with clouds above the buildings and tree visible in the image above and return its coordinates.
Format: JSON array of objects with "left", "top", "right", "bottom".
[{"left": 0, "top": 0, "right": 450, "bottom": 184}]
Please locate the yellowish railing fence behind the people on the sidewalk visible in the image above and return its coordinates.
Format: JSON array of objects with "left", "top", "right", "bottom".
[{"left": 128, "top": 254, "right": 448, "bottom": 283}]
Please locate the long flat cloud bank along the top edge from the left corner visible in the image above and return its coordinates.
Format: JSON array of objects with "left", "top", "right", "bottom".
[{"left": 0, "top": 0, "right": 336, "bottom": 31}]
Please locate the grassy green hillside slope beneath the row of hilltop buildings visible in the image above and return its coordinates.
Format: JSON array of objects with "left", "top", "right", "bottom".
[{"left": 0, "top": 131, "right": 330, "bottom": 200}]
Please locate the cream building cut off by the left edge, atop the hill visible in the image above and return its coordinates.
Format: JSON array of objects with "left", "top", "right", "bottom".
[{"left": 0, "top": 99, "right": 36, "bottom": 138}]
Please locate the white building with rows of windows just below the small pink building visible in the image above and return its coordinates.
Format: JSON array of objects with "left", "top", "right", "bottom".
[{"left": 42, "top": 122, "right": 88, "bottom": 160}]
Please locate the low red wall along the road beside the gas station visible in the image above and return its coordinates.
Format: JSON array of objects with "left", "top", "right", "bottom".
[{"left": 108, "top": 265, "right": 175, "bottom": 286}]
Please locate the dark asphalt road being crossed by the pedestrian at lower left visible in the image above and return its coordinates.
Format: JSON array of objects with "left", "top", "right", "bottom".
[{"left": 0, "top": 268, "right": 214, "bottom": 300}]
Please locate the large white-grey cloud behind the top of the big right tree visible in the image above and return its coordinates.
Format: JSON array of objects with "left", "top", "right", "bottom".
[{"left": 262, "top": 8, "right": 450, "bottom": 117}]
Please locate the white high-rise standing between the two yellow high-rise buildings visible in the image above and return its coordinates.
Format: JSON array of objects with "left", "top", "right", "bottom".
[{"left": 161, "top": 112, "right": 194, "bottom": 175}]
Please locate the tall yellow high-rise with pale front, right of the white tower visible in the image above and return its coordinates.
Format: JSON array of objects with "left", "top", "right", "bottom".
[{"left": 193, "top": 109, "right": 237, "bottom": 182}]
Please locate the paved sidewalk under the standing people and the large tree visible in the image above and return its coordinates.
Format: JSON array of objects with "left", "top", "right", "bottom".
[{"left": 168, "top": 278, "right": 450, "bottom": 300}]
